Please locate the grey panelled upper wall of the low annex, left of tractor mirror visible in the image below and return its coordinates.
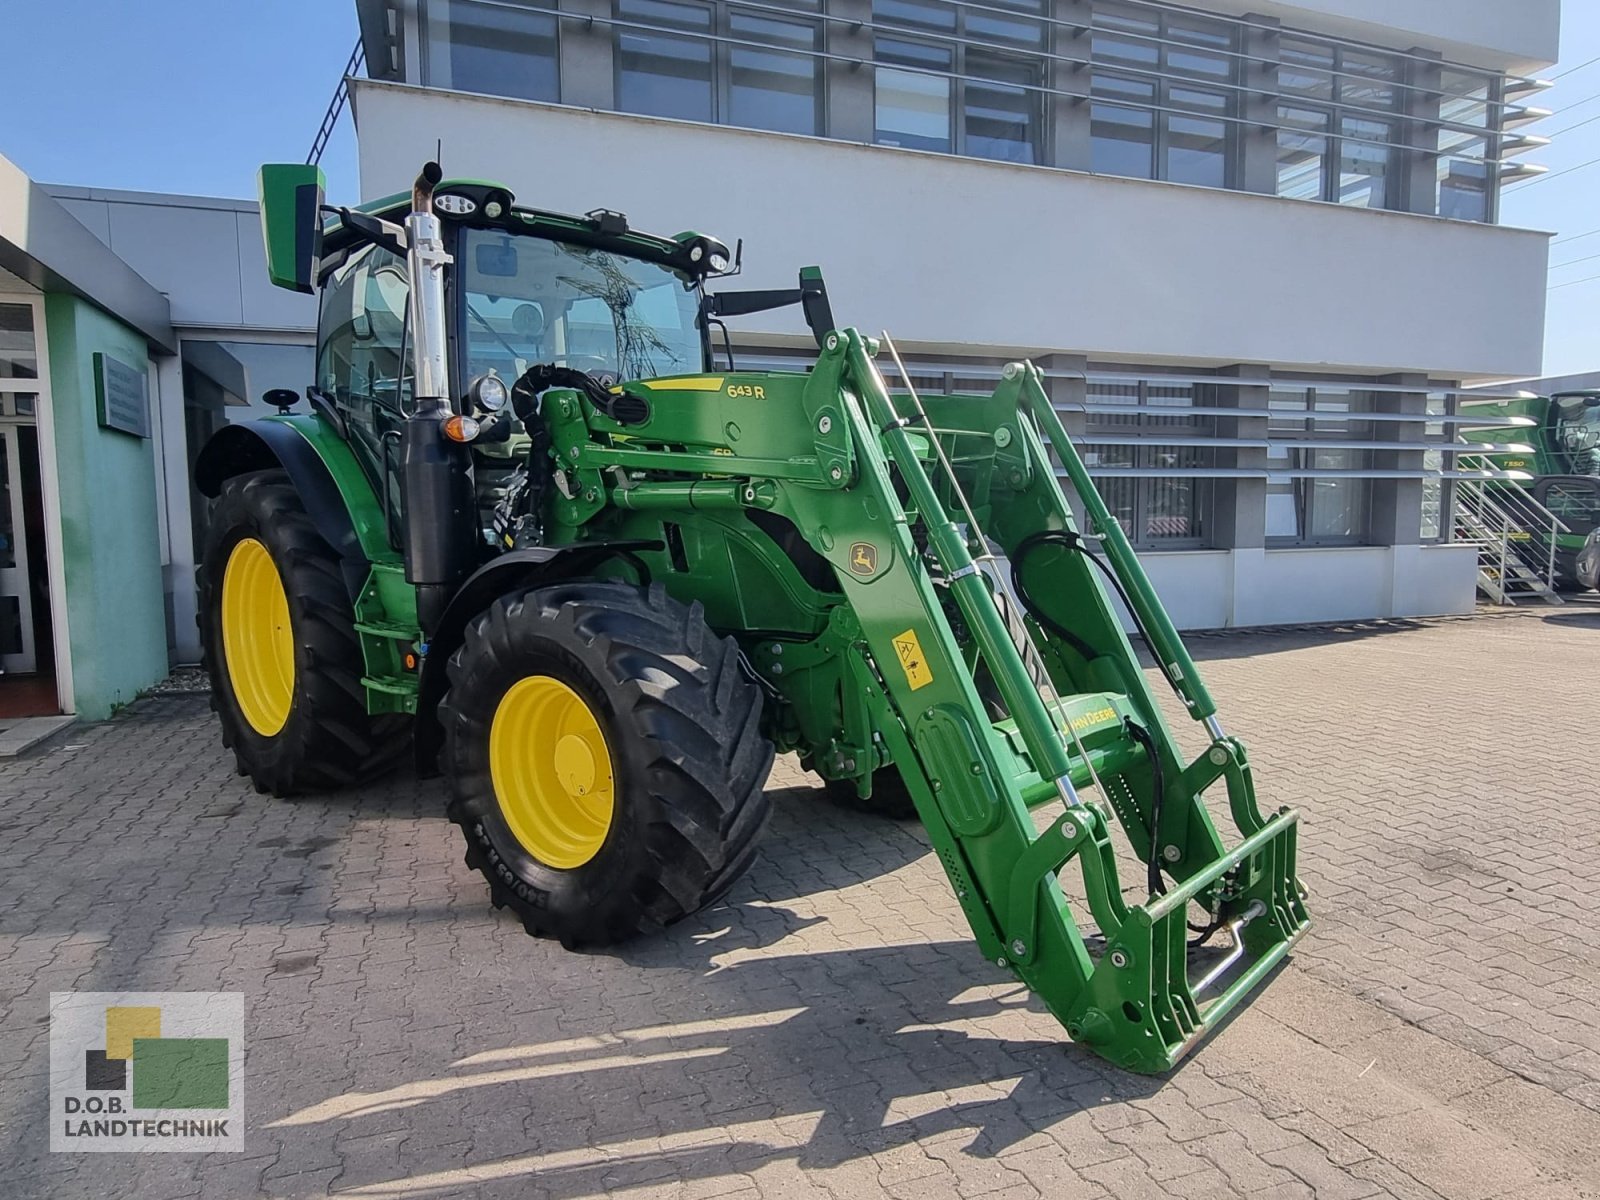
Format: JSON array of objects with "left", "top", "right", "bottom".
[{"left": 48, "top": 187, "right": 317, "bottom": 339}]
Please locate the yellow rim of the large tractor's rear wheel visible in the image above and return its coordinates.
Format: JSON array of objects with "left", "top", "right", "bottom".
[{"left": 222, "top": 538, "right": 294, "bottom": 738}]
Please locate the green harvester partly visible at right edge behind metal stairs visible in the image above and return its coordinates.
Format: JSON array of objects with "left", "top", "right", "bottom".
[{"left": 1461, "top": 390, "right": 1600, "bottom": 589}]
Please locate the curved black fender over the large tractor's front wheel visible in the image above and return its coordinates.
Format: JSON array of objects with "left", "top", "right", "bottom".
[{"left": 413, "top": 539, "right": 662, "bottom": 779}]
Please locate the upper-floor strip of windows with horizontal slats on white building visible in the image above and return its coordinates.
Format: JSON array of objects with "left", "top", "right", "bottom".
[{"left": 422, "top": 0, "right": 1515, "bottom": 221}]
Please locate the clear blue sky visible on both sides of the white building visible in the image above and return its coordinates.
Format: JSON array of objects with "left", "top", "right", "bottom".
[{"left": 0, "top": 0, "right": 1600, "bottom": 374}]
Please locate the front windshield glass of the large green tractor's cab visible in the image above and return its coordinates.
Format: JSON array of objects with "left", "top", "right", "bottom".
[{"left": 458, "top": 229, "right": 704, "bottom": 381}]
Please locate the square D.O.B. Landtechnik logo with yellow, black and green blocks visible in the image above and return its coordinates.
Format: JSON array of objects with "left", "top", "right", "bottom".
[{"left": 50, "top": 992, "right": 245, "bottom": 1152}]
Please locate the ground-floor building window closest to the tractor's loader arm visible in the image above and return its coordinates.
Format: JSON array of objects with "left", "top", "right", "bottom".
[{"left": 1082, "top": 379, "right": 1216, "bottom": 550}]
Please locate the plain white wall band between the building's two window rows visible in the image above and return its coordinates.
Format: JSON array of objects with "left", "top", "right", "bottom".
[{"left": 355, "top": 82, "right": 1547, "bottom": 378}]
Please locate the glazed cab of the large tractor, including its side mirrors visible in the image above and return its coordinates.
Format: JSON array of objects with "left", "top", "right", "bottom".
[{"left": 261, "top": 166, "right": 832, "bottom": 572}]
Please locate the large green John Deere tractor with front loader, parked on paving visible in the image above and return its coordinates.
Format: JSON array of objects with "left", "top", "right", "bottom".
[{"left": 197, "top": 165, "right": 1307, "bottom": 1072}]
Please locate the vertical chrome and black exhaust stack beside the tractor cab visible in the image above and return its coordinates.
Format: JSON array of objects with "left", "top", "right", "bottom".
[{"left": 402, "top": 163, "right": 480, "bottom": 637}]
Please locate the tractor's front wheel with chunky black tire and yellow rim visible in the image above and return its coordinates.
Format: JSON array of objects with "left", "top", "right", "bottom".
[{"left": 438, "top": 581, "right": 773, "bottom": 949}]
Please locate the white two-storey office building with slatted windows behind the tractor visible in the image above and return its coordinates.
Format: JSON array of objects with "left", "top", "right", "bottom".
[{"left": 352, "top": 0, "right": 1560, "bottom": 627}]
